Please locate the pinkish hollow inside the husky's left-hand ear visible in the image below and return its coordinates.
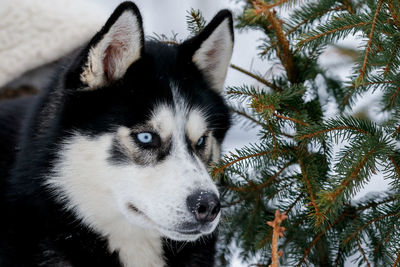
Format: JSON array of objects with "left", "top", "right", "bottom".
[{"left": 103, "top": 39, "right": 126, "bottom": 81}]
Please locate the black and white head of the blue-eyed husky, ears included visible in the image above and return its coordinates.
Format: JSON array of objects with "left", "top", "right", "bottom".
[{"left": 48, "top": 2, "right": 233, "bottom": 240}]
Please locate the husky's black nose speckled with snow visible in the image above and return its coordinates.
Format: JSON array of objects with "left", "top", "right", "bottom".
[{"left": 186, "top": 191, "right": 221, "bottom": 223}]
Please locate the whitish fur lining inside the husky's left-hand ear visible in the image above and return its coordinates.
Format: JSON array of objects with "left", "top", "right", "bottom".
[{"left": 81, "top": 10, "right": 142, "bottom": 89}]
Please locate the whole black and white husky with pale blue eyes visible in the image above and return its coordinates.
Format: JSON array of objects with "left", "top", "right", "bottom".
[{"left": 0, "top": 2, "right": 233, "bottom": 267}]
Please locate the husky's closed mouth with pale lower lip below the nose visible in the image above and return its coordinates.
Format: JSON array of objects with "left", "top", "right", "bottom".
[{"left": 127, "top": 203, "right": 209, "bottom": 240}]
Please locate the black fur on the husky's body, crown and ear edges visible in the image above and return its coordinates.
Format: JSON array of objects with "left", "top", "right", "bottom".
[{"left": 0, "top": 2, "right": 231, "bottom": 267}]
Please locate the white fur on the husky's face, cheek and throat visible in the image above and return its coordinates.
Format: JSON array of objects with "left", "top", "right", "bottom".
[{"left": 47, "top": 101, "right": 220, "bottom": 267}]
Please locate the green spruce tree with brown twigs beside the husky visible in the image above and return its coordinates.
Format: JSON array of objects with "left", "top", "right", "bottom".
[{"left": 188, "top": 0, "right": 400, "bottom": 267}]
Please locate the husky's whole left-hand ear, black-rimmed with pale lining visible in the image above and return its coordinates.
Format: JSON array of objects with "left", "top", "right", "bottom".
[{"left": 68, "top": 2, "right": 144, "bottom": 90}]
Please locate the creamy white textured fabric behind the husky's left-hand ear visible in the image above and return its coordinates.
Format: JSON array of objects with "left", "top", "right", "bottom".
[{"left": 0, "top": 0, "right": 110, "bottom": 87}]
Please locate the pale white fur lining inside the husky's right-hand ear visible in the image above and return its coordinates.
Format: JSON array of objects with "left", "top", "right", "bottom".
[{"left": 193, "top": 19, "right": 233, "bottom": 92}]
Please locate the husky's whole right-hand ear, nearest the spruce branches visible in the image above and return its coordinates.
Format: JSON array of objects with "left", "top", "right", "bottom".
[{"left": 180, "top": 10, "right": 234, "bottom": 93}]
